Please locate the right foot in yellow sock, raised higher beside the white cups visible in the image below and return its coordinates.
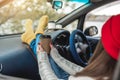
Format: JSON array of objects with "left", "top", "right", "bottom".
[{"left": 35, "top": 15, "right": 49, "bottom": 35}]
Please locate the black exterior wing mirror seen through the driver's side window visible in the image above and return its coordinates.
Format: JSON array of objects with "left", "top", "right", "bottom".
[{"left": 84, "top": 26, "right": 98, "bottom": 36}]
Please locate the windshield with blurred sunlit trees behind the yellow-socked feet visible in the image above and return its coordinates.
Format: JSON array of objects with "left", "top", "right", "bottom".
[{"left": 0, "top": 0, "right": 88, "bottom": 35}]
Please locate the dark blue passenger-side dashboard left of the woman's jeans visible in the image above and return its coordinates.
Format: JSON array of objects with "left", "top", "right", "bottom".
[{"left": 0, "top": 35, "right": 39, "bottom": 80}]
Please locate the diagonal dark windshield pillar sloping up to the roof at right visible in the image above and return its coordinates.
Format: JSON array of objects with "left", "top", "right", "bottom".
[{"left": 57, "top": 0, "right": 117, "bottom": 27}]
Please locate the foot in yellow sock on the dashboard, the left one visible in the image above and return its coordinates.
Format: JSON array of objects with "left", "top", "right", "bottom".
[{"left": 21, "top": 19, "right": 35, "bottom": 44}]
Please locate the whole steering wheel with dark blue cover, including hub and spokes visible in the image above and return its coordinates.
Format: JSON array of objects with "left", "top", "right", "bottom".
[{"left": 69, "top": 30, "right": 92, "bottom": 67}]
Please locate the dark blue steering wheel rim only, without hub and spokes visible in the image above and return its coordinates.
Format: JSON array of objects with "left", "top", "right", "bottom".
[{"left": 69, "top": 30, "right": 92, "bottom": 67}]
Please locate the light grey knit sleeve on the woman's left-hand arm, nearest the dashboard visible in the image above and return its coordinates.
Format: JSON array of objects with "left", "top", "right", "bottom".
[{"left": 37, "top": 52, "right": 58, "bottom": 80}]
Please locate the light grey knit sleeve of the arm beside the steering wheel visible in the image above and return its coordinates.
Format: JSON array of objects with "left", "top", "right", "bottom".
[{"left": 50, "top": 48, "right": 83, "bottom": 75}]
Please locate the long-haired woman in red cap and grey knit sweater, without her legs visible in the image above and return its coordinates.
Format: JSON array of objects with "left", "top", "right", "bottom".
[{"left": 38, "top": 15, "right": 120, "bottom": 80}]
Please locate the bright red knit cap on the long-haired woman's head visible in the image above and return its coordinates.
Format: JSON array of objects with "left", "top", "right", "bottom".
[{"left": 102, "top": 15, "right": 120, "bottom": 60}]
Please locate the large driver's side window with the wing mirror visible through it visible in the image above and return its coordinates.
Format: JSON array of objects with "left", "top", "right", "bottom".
[{"left": 83, "top": 1, "right": 120, "bottom": 38}]
